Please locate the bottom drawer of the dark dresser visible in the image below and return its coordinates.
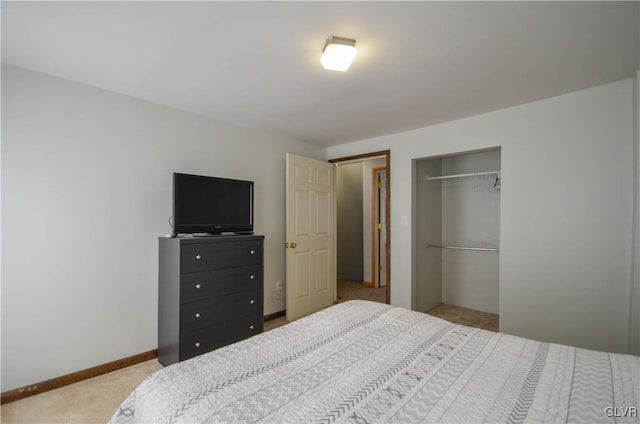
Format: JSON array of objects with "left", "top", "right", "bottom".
[{"left": 179, "top": 314, "right": 263, "bottom": 361}]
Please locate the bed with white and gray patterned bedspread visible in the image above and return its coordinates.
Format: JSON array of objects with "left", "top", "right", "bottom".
[{"left": 111, "top": 301, "right": 640, "bottom": 424}]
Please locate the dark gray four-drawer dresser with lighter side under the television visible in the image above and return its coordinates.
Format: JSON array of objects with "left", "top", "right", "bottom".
[{"left": 158, "top": 235, "right": 264, "bottom": 366}]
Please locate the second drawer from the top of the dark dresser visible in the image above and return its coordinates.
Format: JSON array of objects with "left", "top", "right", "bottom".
[{"left": 180, "top": 265, "right": 263, "bottom": 303}]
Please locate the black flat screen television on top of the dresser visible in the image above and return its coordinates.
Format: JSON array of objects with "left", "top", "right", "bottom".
[{"left": 173, "top": 173, "right": 253, "bottom": 235}]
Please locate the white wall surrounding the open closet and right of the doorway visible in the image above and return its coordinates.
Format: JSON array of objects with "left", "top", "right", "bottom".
[{"left": 327, "top": 79, "right": 634, "bottom": 352}]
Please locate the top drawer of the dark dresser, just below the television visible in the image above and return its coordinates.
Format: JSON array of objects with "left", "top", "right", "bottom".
[{"left": 180, "top": 240, "right": 262, "bottom": 274}]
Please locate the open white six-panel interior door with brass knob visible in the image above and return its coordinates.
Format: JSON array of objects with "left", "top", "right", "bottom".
[{"left": 286, "top": 154, "right": 336, "bottom": 321}]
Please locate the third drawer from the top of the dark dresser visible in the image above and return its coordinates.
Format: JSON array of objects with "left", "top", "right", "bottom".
[{"left": 180, "top": 292, "right": 262, "bottom": 332}]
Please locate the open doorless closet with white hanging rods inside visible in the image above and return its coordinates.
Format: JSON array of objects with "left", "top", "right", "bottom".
[{"left": 412, "top": 148, "right": 502, "bottom": 331}]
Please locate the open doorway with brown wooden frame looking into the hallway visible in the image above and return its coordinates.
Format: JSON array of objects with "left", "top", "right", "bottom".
[{"left": 329, "top": 150, "right": 391, "bottom": 304}]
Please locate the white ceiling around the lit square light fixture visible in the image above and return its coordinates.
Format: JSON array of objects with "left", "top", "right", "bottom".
[{"left": 1, "top": 1, "right": 640, "bottom": 145}]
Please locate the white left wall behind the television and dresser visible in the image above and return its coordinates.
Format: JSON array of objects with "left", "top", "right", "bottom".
[{"left": 1, "top": 67, "right": 325, "bottom": 391}]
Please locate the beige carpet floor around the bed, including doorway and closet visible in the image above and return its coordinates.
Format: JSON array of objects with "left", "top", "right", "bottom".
[{"left": 0, "top": 296, "right": 498, "bottom": 424}]
